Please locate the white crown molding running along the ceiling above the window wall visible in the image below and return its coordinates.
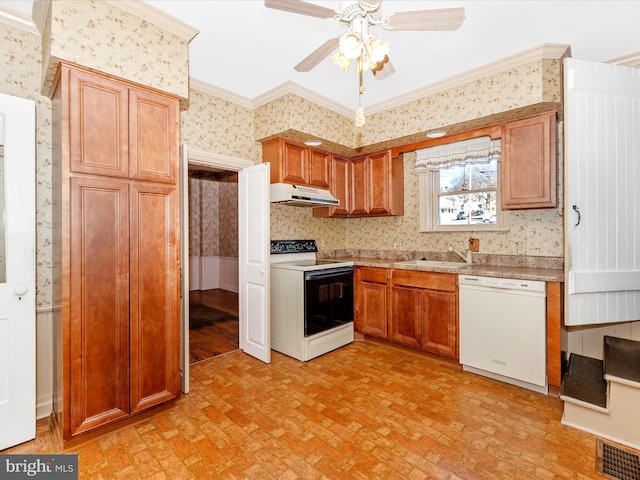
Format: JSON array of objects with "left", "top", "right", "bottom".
[{"left": 367, "top": 43, "right": 571, "bottom": 115}]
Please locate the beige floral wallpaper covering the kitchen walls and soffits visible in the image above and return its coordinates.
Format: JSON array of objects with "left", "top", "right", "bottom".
[{"left": 0, "top": 2, "right": 563, "bottom": 307}]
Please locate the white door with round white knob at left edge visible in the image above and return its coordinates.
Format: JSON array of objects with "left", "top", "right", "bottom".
[{"left": 0, "top": 95, "right": 36, "bottom": 450}]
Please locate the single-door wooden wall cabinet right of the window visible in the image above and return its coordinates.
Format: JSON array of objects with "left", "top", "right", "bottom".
[{"left": 501, "top": 112, "right": 557, "bottom": 210}]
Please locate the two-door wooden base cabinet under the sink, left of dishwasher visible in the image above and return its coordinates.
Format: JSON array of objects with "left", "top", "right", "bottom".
[{"left": 389, "top": 270, "right": 458, "bottom": 358}]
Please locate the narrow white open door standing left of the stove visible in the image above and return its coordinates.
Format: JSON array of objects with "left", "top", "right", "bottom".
[{"left": 238, "top": 163, "right": 271, "bottom": 363}]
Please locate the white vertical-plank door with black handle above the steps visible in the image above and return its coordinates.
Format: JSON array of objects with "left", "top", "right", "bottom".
[{"left": 564, "top": 58, "right": 640, "bottom": 325}]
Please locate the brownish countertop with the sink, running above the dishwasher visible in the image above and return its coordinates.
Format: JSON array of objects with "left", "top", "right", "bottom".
[{"left": 322, "top": 256, "right": 564, "bottom": 282}]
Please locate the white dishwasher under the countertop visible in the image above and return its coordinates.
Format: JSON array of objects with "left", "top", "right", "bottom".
[{"left": 458, "top": 275, "right": 547, "bottom": 394}]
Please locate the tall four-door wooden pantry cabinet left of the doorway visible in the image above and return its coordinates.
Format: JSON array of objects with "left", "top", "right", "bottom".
[{"left": 52, "top": 63, "right": 180, "bottom": 440}]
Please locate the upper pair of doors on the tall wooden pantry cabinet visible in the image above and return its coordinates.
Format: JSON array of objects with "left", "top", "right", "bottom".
[{"left": 66, "top": 64, "right": 179, "bottom": 184}]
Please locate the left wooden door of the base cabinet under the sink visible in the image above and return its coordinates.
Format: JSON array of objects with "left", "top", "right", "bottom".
[{"left": 389, "top": 286, "right": 420, "bottom": 348}]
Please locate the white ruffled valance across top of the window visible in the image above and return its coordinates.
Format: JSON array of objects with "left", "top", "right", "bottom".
[{"left": 415, "top": 137, "right": 501, "bottom": 173}]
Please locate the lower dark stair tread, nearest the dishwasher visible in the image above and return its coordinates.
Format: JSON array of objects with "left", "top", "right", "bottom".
[{"left": 560, "top": 353, "right": 607, "bottom": 408}]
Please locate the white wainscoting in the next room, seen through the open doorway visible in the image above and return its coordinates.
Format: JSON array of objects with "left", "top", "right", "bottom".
[{"left": 189, "top": 257, "right": 238, "bottom": 293}]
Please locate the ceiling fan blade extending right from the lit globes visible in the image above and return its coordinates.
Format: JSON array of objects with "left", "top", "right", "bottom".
[{"left": 382, "top": 7, "right": 464, "bottom": 30}]
